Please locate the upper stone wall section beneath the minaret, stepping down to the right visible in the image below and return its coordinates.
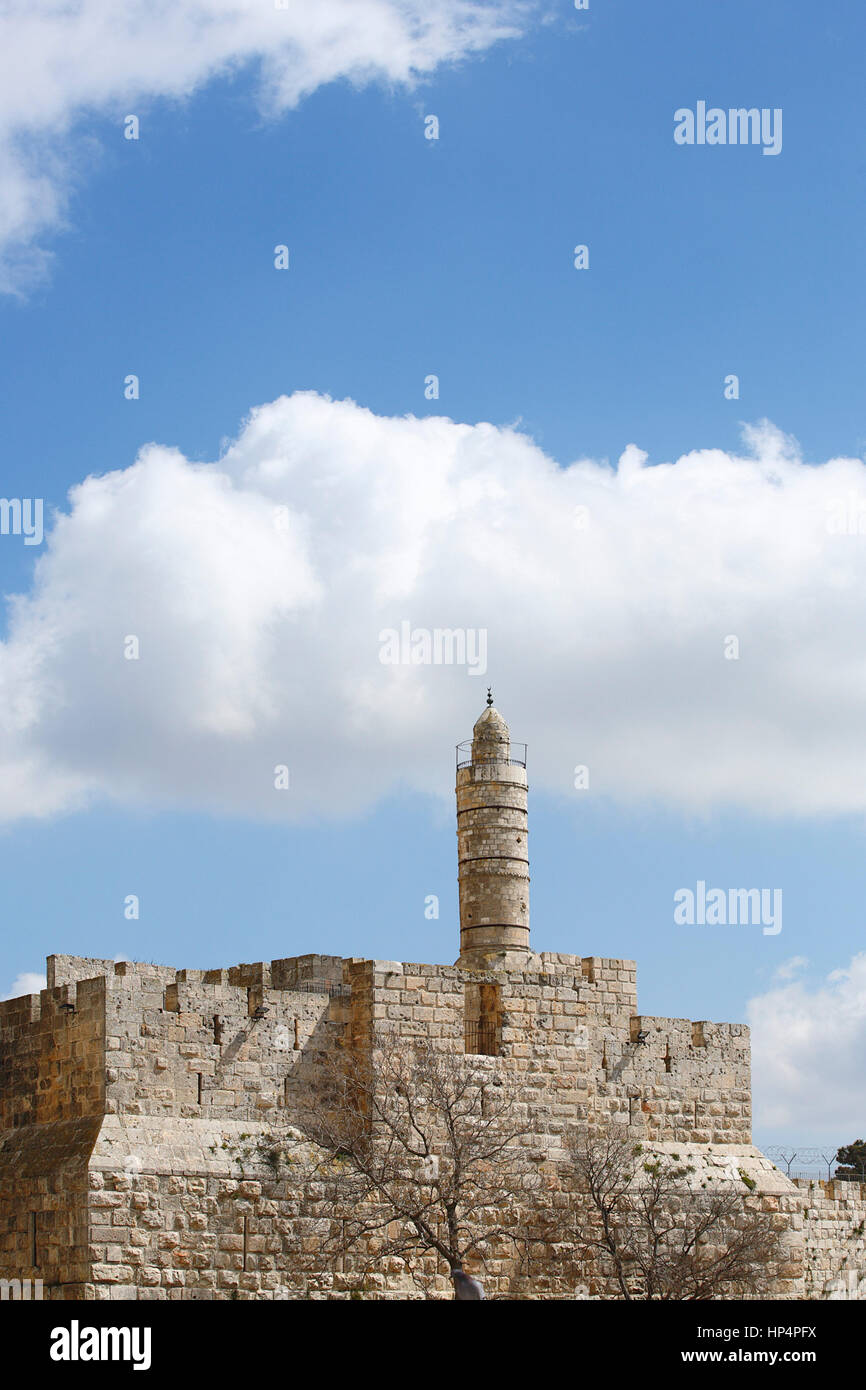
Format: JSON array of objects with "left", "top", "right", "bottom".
[{"left": 349, "top": 954, "right": 751, "bottom": 1151}]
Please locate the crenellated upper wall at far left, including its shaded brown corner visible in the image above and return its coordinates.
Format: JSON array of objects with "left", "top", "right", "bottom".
[{"left": 0, "top": 955, "right": 343, "bottom": 1130}]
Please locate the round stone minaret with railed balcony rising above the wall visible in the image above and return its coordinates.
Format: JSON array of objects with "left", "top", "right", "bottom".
[{"left": 457, "top": 689, "right": 531, "bottom": 970}]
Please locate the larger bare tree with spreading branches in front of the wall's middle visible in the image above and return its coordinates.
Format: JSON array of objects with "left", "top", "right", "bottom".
[{"left": 284, "top": 1034, "right": 537, "bottom": 1287}]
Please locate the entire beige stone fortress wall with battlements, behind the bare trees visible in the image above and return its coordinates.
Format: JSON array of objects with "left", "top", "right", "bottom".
[{"left": 0, "top": 954, "right": 845, "bottom": 1300}]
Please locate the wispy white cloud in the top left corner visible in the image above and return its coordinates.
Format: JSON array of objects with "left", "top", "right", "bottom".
[{"left": 0, "top": 0, "right": 530, "bottom": 291}]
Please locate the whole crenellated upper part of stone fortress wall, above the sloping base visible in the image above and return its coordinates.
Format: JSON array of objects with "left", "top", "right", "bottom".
[{"left": 0, "top": 952, "right": 751, "bottom": 1143}]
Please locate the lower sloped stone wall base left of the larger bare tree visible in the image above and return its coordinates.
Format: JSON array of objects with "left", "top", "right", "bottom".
[{"left": 85, "top": 1106, "right": 547, "bottom": 1301}]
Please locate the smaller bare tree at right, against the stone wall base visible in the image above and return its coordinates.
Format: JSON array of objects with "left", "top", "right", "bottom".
[{"left": 558, "top": 1130, "right": 783, "bottom": 1301}]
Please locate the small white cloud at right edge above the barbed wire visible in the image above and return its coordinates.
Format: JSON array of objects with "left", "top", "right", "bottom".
[{"left": 748, "top": 951, "right": 866, "bottom": 1145}]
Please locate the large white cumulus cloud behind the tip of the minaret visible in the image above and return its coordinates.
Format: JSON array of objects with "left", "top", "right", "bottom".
[{"left": 0, "top": 392, "right": 866, "bottom": 820}]
